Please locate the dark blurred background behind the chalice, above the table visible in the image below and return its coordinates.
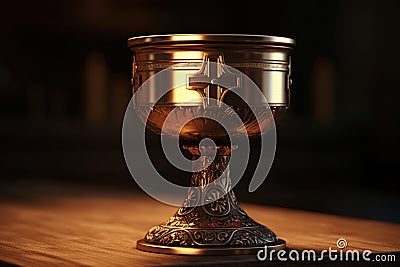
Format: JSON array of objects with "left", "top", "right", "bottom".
[{"left": 0, "top": 0, "right": 400, "bottom": 223}]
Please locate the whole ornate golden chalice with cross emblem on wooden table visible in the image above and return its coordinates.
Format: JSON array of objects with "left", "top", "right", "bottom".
[{"left": 123, "top": 34, "right": 295, "bottom": 255}]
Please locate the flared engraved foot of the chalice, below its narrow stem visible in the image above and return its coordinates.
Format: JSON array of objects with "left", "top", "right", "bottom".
[{"left": 136, "top": 191, "right": 286, "bottom": 255}]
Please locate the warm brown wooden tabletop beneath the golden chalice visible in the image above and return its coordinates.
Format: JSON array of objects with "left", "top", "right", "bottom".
[{"left": 0, "top": 183, "right": 400, "bottom": 266}]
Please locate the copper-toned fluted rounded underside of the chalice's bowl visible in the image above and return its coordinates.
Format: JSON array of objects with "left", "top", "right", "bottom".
[{"left": 138, "top": 106, "right": 285, "bottom": 145}]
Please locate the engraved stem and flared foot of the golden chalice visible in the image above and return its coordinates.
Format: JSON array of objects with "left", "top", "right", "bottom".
[{"left": 137, "top": 147, "right": 286, "bottom": 254}]
